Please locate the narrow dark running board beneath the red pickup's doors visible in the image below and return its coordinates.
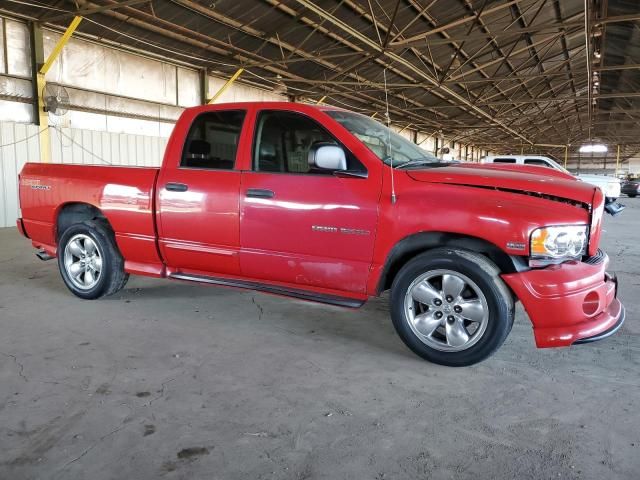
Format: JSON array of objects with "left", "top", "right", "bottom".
[{"left": 169, "top": 273, "right": 364, "bottom": 308}]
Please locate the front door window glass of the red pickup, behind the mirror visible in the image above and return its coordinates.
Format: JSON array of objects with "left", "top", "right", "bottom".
[{"left": 253, "top": 110, "right": 360, "bottom": 175}]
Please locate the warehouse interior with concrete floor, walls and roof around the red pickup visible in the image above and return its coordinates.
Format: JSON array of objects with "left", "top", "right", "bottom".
[{"left": 0, "top": 0, "right": 640, "bottom": 479}]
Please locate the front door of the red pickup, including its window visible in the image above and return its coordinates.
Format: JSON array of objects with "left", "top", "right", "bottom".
[{"left": 240, "top": 110, "right": 380, "bottom": 293}]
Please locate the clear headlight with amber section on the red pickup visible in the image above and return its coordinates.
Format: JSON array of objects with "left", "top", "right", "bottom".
[{"left": 531, "top": 225, "right": 589, "bottom": 260}]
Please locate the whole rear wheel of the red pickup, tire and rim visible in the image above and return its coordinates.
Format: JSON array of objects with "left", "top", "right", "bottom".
[{"left": 58, "top": 220, "right": 129, "bottom": 300}]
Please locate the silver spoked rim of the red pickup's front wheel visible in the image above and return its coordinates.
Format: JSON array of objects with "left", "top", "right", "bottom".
[{"left": 405, "top": 270, "right": 489, "bottom": 352}]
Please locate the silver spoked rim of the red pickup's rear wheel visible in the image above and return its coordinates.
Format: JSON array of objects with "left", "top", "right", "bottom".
[{"left": 64, "top": 233, "right": 102, "bottom": 290}]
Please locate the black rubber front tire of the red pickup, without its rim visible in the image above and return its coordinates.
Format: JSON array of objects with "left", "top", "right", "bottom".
[{"left": 390, "top": 248, "right": 514, "bottom": 367}]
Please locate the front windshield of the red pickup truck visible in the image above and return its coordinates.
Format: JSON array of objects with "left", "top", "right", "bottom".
[{"left": 325, "top": 110, "right": 440, "bottom": 167}]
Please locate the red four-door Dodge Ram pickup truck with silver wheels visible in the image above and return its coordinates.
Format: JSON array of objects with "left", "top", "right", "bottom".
[{"left": 18, "top": 103, "right": 624, "bottom": 366}]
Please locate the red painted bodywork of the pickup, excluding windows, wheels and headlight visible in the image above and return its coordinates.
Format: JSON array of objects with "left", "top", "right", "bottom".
[{"left": 18, "top": 102, "right": 622, "bottom": 347}]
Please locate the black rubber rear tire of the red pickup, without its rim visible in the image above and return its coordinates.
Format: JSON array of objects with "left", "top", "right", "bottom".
[{"left": 58, "top": 220, "right": 129, "bottom": 300}]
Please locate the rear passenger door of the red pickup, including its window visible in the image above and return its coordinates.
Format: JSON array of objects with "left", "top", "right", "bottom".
[{"left": 157, "top": 110, "right": 246, "bottom": 275}]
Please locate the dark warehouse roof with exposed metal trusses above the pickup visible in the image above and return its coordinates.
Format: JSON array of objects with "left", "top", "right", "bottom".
[{"left": 5, "top": 0, "right": 640, "bottom": 153}]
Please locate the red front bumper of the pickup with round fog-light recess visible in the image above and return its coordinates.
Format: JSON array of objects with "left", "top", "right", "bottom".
[{"left": 503, "top": 253, "right": 625, "bottom": 348}]
